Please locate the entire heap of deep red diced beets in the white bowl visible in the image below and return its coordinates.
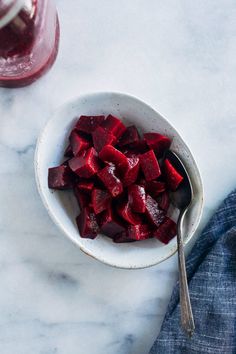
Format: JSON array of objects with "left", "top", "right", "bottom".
[{"left": 48, "top": 115, "right": 183, "bottom": 244}]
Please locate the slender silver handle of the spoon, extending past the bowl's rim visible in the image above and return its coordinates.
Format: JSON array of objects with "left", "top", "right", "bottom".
[{"left": 177, "top": 209, "right": 195, "bottom": 337}]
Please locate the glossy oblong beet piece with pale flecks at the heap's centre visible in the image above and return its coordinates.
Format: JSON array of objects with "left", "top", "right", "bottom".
[{"left": 97, "top": 165, "right": 123, "bottom": 197}]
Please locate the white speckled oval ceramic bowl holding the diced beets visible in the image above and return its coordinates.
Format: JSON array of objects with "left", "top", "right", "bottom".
[{"left": 35, "top": 92, "right": 203, "bottom": 268}]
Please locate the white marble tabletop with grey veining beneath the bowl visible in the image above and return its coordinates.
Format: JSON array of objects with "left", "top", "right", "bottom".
[{"left": 0, "top": 0, "right": 236, "bottom": 354}]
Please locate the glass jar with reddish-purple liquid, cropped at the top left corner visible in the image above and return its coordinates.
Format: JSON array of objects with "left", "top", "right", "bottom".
[{"left": 0, "top": 0, "right": 59, "bottom": 87}]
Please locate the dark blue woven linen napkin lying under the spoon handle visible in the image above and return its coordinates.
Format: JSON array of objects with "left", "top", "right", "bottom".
[{"left": 150, "top": 191, "right": 236, "bottom": 354}]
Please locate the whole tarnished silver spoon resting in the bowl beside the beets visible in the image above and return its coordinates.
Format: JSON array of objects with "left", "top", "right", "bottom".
[{"left": 165, "top": 150, "right": 195, "bottom": 337}]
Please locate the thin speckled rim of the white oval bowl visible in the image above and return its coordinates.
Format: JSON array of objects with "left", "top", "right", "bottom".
[{"left": 34, "top": 91, "right": 204, "bottom": 269}]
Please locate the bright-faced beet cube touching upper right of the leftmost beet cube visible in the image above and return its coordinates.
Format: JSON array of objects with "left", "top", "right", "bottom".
[{"left": 69, "top": 147, "right": 99, "bottom": 178}]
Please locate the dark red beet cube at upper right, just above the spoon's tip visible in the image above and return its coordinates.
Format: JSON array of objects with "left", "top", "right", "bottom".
[{"left": 143, "top": 133, "right": 171, "bottom": 157}]
